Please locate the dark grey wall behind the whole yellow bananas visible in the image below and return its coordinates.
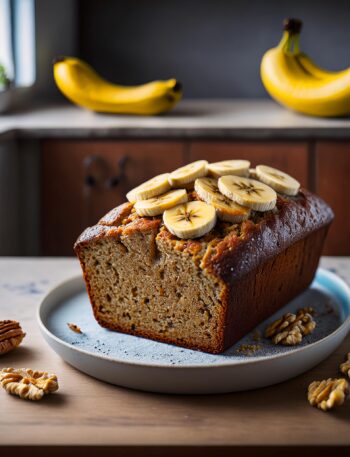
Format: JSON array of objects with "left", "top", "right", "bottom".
[{"left": 79, "top": 0, "right": 350, "bottom": 98}]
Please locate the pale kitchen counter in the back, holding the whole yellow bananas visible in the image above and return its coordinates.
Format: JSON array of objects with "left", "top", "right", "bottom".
[{"left": 0, "top": 100, "right": 350, "bottom": 139}]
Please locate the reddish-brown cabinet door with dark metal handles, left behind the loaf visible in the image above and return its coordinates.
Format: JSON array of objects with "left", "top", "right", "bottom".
[{"left": 41, "top": 140, "right": 185, "bottom": 255}]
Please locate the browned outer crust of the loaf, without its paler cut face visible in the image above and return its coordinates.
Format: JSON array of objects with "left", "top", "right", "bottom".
[{"left": 74, "top": 189, "right": 333, "bottom": 353}]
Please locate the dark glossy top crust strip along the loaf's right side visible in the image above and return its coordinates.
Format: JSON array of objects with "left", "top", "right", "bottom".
[{"left": 201, "top": 189, "right": 333, "bottom": 282}]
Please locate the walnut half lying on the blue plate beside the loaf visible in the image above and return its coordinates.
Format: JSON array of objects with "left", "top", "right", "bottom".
[{"left": 265, "top": 308, "right": 316, "bottom": 346}]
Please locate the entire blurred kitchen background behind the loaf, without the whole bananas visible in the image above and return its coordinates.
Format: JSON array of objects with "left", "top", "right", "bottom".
[{"left": 0, "top": 0, "right": 350, "bottom": 255}]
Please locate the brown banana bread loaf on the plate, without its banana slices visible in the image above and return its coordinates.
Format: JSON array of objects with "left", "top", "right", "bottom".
[{"left": 75, "top": 162, "right": 333, "bottom": 353}]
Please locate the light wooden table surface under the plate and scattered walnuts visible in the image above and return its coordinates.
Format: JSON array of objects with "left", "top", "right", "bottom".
[{"left": 0, "top": 257, "right": 350, "bottom": 456}]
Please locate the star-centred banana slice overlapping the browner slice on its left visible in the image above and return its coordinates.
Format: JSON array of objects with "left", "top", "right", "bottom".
[{"left": 218, "top": 176, "right": 277, "bottom": 211}]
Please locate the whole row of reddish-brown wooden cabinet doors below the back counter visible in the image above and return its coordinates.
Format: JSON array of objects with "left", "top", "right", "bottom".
[{"left": 41, "top": 140, "right": 350, "bottom": 255}]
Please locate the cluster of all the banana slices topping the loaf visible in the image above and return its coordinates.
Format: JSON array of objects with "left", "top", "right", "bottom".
[{"left": 126, "top": 160, "right": 300, "bottom": 239}]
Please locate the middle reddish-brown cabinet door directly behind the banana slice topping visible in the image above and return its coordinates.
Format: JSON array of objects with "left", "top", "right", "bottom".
[{"left": 190, "top": 141, "right": 309, "bottom": 187}]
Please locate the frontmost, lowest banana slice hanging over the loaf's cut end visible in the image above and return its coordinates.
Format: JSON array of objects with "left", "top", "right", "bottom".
[{"left": 163, "top": 201, "right": 216, "bottom": 239}]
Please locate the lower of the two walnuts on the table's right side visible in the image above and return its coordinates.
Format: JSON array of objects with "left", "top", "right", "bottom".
[{"left": 307, "top": 378, "right": 349, "bottom": 411}]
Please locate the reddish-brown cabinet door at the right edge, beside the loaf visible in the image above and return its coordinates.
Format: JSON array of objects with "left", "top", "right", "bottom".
[{"left": 315, "top": 141, "right": 350, "bottom": 255}]
